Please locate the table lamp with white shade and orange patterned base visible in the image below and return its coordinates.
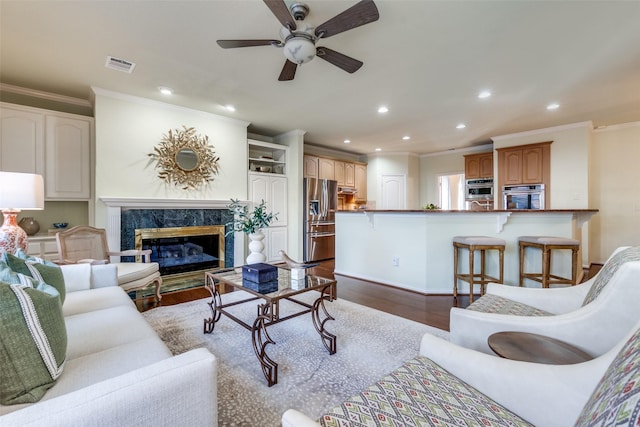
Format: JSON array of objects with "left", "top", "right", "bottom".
[{"left": 0, "top": 172, "right": 44, "bottom": 254}]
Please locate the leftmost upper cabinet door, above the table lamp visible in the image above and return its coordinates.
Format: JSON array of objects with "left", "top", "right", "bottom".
[{"left": 0, "top": 105, "right": 44, "bottom": 175}]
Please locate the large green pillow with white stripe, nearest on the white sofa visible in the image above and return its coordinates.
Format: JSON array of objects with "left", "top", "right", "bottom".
[{"left": 0, "top": 282, "right": 67, "bottom": 405}]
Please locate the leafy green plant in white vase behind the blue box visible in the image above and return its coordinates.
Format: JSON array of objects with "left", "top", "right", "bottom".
[{"left": 226, "top": 199, "right": 278, "bottom": 264}]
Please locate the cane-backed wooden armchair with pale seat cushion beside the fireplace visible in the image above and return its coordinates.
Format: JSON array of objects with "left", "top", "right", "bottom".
[{"left": 56, "top": 225, "right": 162, "bottom": 301}]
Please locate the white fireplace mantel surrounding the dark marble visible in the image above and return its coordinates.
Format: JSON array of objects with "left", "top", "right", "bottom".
[{"left": 99, "top": 197, "right": 249, "bottom": 265}]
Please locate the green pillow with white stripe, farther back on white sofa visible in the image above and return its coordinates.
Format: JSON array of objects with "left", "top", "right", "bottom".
[{"left": 0, "top": 254, "right": 66, "bottom": 304}]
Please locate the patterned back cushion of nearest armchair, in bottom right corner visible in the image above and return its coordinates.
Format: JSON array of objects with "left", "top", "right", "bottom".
[{"left": 576, "top": 329, "right": 640, "bottom": 427}]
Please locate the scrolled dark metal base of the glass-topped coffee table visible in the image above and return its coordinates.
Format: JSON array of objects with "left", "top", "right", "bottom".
[{"left": 203, "top": 282, "right": 336, "bottom": 387}]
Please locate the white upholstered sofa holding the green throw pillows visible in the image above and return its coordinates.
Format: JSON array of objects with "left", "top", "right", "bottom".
[{"left": 0, "top": 264, "right": 217, "bottom": 427}]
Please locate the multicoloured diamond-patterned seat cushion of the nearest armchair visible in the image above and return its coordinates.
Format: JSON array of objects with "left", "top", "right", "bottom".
[{"left": 319, "top": 356, "right": 531, "bottom": 427}]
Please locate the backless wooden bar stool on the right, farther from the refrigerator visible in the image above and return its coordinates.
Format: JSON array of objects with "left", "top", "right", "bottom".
[{"left": 518, "top": 236, "right": 580, "bottom": 288}]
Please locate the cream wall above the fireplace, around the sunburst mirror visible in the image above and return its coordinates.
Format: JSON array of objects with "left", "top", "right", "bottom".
[{"left": 94, "top": 89, "right": 248, "bottom": 227}]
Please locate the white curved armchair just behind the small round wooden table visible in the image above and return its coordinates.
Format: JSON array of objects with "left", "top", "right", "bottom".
[{"left": 450, "top": 247, "right": 640, "bottom": 358}]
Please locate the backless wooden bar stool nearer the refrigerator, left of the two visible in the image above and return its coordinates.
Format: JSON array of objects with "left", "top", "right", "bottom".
[{"left": 453, "top": 236, "right": 506, "bottom": 302}]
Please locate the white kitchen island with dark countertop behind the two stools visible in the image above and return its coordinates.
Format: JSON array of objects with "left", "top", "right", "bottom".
[{"left": 335, "top": 209, "right": 598, "bottom": 294}]
